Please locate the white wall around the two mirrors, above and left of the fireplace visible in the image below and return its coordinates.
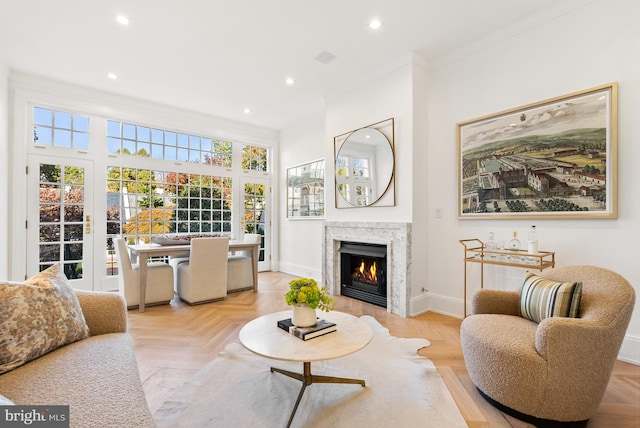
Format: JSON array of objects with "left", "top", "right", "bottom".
[{"left": 279, "top": 58, "right": 413, "bottom": 294}]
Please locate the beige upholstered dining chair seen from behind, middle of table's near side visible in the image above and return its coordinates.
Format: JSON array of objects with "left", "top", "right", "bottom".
[{"left": 176, "top": 237, "right": 229, "bottom": 305}]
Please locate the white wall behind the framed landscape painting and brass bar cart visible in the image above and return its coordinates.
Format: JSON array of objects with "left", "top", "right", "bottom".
[{"left": 424, "top": 0, "right": 640, "bottom": 363}]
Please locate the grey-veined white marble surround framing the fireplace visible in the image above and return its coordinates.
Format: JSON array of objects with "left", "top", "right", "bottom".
[{"left": 322, "top": 221, "right": 411, "bottom": 317}]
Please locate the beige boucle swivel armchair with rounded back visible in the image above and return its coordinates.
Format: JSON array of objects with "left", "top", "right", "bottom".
[{"left": 460, "top": 266, "right": 635, "bottom": 427}]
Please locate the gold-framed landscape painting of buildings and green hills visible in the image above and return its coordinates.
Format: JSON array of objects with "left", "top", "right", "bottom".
[{"left": 457, "top": 82, "right": 618, "bottom": 219}]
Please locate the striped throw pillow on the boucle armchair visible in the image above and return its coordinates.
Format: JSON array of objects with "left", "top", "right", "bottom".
[{"left": 520, "top": 272, "right": 582, "bottom": 322}]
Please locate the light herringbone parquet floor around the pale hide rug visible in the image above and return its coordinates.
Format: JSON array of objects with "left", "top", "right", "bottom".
[{"left": 129, "top": 272, "right": 640, "bottom": 428}]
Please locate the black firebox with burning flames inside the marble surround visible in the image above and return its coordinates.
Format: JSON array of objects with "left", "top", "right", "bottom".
[{"left": 339, "top": 241, "right": 387, "bottom": 308}]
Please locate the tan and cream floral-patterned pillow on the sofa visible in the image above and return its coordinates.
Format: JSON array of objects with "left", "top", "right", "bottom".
[{"left": 0, "top": 263, "right": 89, "bottom": 374}]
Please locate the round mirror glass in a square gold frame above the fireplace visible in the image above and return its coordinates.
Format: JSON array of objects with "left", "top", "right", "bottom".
[{"left": 336, "top": 128, "right": 394, "bottom": 207}]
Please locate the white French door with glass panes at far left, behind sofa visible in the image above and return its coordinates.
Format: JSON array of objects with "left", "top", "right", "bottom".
[{"left": 26, "top": 154, "right": 95, "bottom": 290}]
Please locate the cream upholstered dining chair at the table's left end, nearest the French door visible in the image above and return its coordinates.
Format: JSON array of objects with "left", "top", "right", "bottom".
[{"left": 115, "top": 238, "right": 174, "bottom": 309}]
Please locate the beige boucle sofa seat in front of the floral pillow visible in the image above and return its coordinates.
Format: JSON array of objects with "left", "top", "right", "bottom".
[{"left": 0, "top": 333, "right": 155, "bottom": 428}]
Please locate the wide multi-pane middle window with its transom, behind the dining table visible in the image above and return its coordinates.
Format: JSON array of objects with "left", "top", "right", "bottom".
[{"left": 106, "top": 120, "right": 242, "bottom": 275}]
